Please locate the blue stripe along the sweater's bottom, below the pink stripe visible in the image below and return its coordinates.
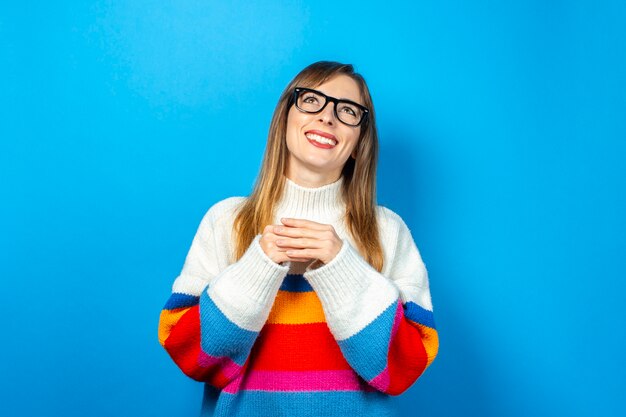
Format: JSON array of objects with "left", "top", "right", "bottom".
[{"left": 206, "top": 388, "right": 390, "bottom": 417}]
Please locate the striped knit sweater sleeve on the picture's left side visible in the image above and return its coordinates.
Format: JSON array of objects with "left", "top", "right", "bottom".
[{"left": 159, "top": 203, "right": 289, "bottom": 389}]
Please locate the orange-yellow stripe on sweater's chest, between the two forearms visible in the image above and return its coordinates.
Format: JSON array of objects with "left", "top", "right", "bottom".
[{"left": 267, "top": 291, "right": 326, "bottom": 324}]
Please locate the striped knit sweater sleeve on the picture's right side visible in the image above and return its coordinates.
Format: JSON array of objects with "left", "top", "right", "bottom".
[{"left": 304, "top": 209, "right": 439, "bottom": 395}]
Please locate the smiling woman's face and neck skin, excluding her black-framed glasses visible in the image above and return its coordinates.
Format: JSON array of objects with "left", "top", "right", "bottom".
[{"left": 286, "top": 75, "right": 363, "bottom": 185}]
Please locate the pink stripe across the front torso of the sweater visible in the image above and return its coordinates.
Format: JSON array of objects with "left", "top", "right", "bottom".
[{"left": 241, "top": 369, "right": 367, "bottom": 391}]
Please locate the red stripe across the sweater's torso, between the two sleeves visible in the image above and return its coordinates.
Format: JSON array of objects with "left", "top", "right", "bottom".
[{"left": 245, "top": 323, "right": 351, "bottom": 371}]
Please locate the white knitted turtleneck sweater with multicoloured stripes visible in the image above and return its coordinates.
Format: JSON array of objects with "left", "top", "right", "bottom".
[{"left": 159, "top": 178, "right": 438, "bottom": 417}]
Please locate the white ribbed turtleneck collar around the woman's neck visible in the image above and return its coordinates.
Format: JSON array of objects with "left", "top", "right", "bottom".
[{"left": 274, "top": 177, "right": 346, "bottom": 228}]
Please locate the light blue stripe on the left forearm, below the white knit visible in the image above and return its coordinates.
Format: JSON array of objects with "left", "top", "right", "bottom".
[{"left": 200, "top": 291, "right": 259, "bottom": 366}]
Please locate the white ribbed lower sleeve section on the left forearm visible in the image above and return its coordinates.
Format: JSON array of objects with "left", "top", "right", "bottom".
[{"left": 207, "top": 235, "right": 289, "bottom": 331}]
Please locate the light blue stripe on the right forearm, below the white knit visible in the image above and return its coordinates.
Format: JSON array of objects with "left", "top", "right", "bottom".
[{"left": 338, "top": 300, "right": 398, "bottom": 381}]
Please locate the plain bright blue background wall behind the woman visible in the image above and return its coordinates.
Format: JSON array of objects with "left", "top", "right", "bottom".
[{"left": 0, "top": 0, "right": 626, "bottom": 417}]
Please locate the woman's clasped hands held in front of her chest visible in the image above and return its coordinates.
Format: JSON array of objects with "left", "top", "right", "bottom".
[{"left": 259, "top": 218, "right": 343, "bottom": 266}]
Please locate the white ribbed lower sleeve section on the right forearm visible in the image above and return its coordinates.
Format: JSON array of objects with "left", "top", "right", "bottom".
[{"left": 304, "top": 239, "right": 399, "bottom": 340}]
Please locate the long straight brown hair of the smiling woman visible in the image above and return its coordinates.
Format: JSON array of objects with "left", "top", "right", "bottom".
[{"left": 234, "top": 61, "right": 383, "bottom": 272}]
